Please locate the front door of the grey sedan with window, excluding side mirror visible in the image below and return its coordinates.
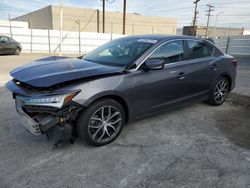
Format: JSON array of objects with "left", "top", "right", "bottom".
[{"left": 131, "top": 40, "right": 186, "bottom": 116}]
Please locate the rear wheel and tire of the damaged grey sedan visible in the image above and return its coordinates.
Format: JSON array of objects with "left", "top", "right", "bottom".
[{"left": 208, "top": 77, "right": 230, "bottom": 106}]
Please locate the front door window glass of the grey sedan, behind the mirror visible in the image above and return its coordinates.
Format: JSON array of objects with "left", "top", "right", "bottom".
[{"left": 149, "top": 40, "right": 184, "bottom": 64}]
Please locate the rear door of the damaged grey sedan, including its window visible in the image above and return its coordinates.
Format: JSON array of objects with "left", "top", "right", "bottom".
[{"left": 185, "top": 40, "right": 218, "bottom": 96}]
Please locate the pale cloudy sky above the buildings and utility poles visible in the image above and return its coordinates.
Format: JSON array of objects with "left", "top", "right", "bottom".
[{"left": 0, "top": 0, "right": 250, "bottom": 30}]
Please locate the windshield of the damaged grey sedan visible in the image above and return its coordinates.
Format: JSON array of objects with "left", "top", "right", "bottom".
[{"left": 83, "top": 38, "right": 157, "bottom": 66}]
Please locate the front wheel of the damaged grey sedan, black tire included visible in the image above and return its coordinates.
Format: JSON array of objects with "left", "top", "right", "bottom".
[{"left": 76, "top": 99, "right": 125, "bottom": 146}]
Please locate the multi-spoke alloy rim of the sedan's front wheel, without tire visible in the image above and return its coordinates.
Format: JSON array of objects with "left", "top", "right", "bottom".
[{"left": 88, "top": 106, "right": 122, "bottom": 143}]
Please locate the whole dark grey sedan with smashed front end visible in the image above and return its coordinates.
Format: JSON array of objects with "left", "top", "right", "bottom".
[{"left": 6, "top": 35, "right": 237, "bottom": 146}]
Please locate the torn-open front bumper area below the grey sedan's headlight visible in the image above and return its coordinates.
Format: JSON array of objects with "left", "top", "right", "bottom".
[{"left": 15, "top": 99, "right": 82, "bottom": 138}]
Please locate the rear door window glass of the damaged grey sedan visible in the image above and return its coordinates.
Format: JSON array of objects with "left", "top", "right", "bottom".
[{"left": 187, "top": 40, "right": 213, "bottom": 59}]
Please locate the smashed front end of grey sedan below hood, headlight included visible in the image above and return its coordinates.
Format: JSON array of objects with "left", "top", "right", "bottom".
[{"left": 6, "top": 80, "right": 83, "bottom": 139}]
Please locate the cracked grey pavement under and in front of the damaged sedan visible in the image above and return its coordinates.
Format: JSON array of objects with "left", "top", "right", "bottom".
[{"left": 0, "top": 57, "right": 250, "bottom": 188}]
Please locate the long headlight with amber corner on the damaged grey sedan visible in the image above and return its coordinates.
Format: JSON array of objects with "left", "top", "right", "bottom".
[{"left": 16, "top": 90, "right": 80, "bottom": 108}]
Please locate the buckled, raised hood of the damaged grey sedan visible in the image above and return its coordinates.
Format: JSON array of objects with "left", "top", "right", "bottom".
[{"left": 10, "top": 56, "right": 124, "bottom": 87}]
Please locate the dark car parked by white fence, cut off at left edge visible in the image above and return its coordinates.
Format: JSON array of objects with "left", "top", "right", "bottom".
[{"left": 0, "top": 36, "right": 22, "bottom": 55}]
